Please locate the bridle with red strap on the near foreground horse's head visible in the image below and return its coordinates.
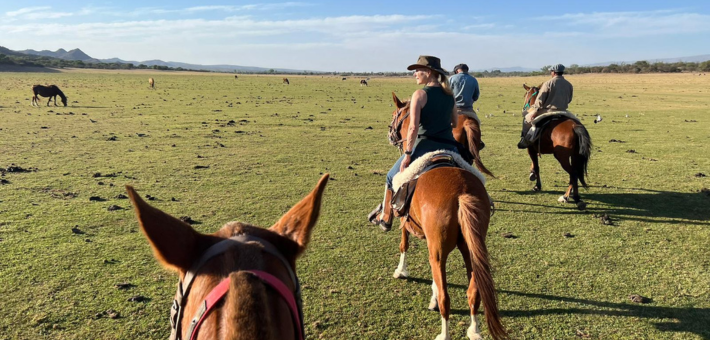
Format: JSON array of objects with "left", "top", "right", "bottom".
[{"left": 170, "top": 234, "right": 305, "bottom": 340}]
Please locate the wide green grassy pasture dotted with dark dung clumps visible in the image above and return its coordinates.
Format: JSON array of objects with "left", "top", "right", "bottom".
[{"left": 0, "top": 71, "right": 710, "bottom": 339}]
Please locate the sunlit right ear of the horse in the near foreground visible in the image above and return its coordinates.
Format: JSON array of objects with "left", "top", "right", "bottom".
[{"left": 269, "top": 174, "right": 329, "bottom": 256}]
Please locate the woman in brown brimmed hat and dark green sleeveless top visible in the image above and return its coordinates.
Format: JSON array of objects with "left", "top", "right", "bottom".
[{"left": 368, "top": 56, "right": 458, "bottom": 231}]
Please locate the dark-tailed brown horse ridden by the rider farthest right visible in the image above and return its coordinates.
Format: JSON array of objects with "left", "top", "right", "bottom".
[{"left": 523, "top": 84, "right": 592, "bottom": 210}]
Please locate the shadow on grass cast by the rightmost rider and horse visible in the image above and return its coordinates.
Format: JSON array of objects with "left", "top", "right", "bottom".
[{"left": 497, "top": 187, "right": 710, "bottom": 226}]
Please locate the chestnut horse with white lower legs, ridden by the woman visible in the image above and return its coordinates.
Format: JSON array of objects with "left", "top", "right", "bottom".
[{"left": 388, "top": 93, "right": 507, "bottom": 340}]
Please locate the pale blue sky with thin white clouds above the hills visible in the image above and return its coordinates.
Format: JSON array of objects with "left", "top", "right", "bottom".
[{"left": 0, "top": 0, "right": 710, "bottom": 72}]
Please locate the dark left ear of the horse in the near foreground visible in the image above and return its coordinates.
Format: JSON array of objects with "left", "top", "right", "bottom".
[{"left": 126, "top": 185, "right": 206, "bottom": 271}]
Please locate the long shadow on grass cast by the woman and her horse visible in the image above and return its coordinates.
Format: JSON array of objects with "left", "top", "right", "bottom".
[{"left": 406, "top": 277, "right": 710, "bottom": 340}]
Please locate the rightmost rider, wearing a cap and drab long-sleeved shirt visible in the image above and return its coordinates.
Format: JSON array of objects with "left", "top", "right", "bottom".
[{"left": 518, "top": 64, "right": 572, "bottom": 149}]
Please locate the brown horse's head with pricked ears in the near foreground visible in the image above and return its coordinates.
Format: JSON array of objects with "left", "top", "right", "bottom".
[{"left": 126, "top": 174, "right": 328, "bottom": 340}]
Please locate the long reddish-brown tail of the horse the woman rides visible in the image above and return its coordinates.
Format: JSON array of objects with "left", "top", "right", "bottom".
[{"left": 458, "top": 194, "right": 508, "bottom": 340}]
